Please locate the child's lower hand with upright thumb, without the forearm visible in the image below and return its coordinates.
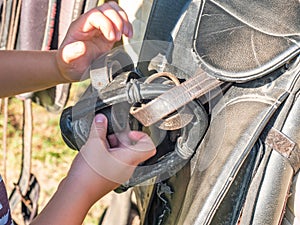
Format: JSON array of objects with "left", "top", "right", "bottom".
[{"left": 80, "top": 114, "right": 156, "bottom": 184}]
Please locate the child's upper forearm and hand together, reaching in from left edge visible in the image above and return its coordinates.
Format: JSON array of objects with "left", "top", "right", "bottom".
[{"left": 0, "top": 2, "right": 132, "bottom": 97}]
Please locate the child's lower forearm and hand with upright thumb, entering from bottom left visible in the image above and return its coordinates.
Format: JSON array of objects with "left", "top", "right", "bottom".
[{"left": 32, "top": 115, "right": 156, "bottom": 225}]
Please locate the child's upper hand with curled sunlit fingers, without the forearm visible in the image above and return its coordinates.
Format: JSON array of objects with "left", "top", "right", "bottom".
[{"left": 56, "top": 1, "right": 133, "bottom": 82}]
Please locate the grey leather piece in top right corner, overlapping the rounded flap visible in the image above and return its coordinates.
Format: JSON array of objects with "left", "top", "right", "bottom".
[{"left": 211, "top": 0, "right": 300, "bottom": 37}]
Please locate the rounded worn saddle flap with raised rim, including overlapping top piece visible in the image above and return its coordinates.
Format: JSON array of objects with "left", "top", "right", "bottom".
[{"left": 194, "top": 0, "right": 300, "bottom": 82}]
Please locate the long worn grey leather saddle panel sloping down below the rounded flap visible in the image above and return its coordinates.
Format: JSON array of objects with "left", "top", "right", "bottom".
[{"left": 178, "top": 57, "right": 299, "bottom": 224}]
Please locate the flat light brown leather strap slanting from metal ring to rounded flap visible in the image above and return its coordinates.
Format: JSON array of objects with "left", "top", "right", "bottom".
[{"left": 130, "top": 71, "right": 224, "bottom": 127}]
